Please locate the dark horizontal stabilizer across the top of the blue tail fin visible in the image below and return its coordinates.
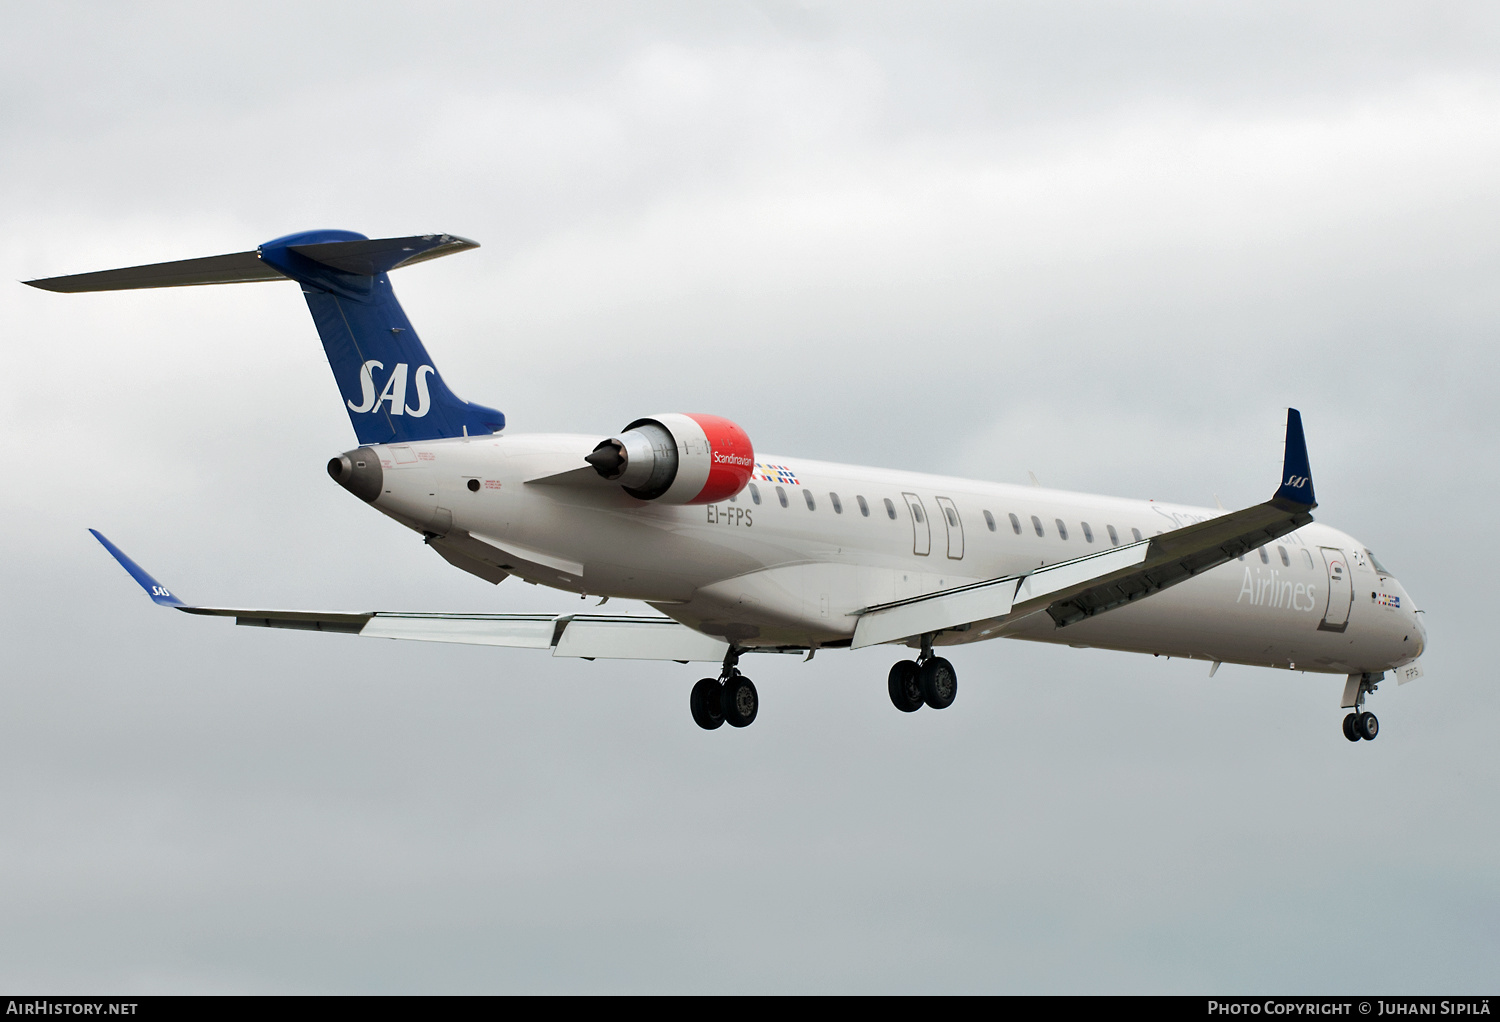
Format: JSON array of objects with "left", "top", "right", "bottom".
[{"left": 27, "top": 234, "right": 479, "bottom": 294}]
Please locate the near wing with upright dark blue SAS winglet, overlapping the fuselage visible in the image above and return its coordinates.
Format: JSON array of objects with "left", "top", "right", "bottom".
[{"left": 852, "top": 408, "right": 1317, "bottom": 648}]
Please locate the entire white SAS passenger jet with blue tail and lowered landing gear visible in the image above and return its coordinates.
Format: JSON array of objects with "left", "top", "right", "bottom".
[{"left": 27, "top": 230, "right": 1427, "bottom": 741}]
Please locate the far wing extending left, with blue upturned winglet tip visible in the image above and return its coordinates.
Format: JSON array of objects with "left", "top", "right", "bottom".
[{"left": 89, "top": 528, "right": 729, "bottom": 663}]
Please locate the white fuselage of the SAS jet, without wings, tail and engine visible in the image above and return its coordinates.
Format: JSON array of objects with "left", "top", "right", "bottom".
[{"left": 357, "top": 434, "right": 1427, "bottom": 674}]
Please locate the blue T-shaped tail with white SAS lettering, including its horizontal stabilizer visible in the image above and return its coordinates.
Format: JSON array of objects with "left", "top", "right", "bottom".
[{"left": 27, "top": 231, "right": 506, "bottom": 444}]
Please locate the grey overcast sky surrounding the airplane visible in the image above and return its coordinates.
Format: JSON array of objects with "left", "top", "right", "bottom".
[{"left": 0, "top": 0, "right": 1500, "bottom": 993}]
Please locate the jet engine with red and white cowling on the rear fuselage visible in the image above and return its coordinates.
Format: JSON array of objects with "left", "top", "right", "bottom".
[{"left": 587, "top": 411, "right": 755, "bottom": 504}]
